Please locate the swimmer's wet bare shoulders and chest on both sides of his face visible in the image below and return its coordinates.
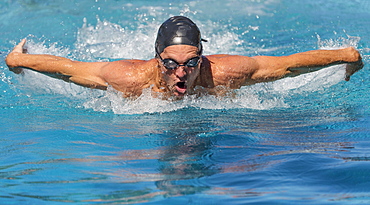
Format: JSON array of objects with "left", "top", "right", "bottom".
[{"left": 101, "top": 55, "right": 256, "bottom": 96}]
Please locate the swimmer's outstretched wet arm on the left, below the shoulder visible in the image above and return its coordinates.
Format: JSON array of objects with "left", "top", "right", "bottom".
[{"left": 5, "top": 39, "right": 108, "bottom": 89}]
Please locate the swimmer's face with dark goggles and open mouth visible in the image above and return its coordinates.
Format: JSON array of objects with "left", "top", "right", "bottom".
[{"left": 158, "top": 45, "right": 202, "bottom": 96}]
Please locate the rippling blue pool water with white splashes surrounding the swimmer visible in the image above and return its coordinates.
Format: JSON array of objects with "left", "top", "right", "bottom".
[{"left": 0, "top": 0, "right": 370, "bottom": 204}]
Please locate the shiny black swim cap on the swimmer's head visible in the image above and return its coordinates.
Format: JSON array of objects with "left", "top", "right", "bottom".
[{"left": 155, "top": 16, "right": 205, "bottom": 55}]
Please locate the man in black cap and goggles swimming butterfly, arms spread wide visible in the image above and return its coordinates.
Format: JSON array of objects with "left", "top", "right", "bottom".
[{"left": 6, "top": 16, "right": 363, "bottom": 98}]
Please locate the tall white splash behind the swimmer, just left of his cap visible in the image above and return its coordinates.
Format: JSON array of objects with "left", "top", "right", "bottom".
[{"left": 75, "top": 17, "right": 158, "bottom": 60}]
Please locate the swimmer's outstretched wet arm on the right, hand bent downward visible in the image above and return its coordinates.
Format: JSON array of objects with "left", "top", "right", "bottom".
[{"left": 251, "top": 47, "right": 363, "bottom": 82}]
